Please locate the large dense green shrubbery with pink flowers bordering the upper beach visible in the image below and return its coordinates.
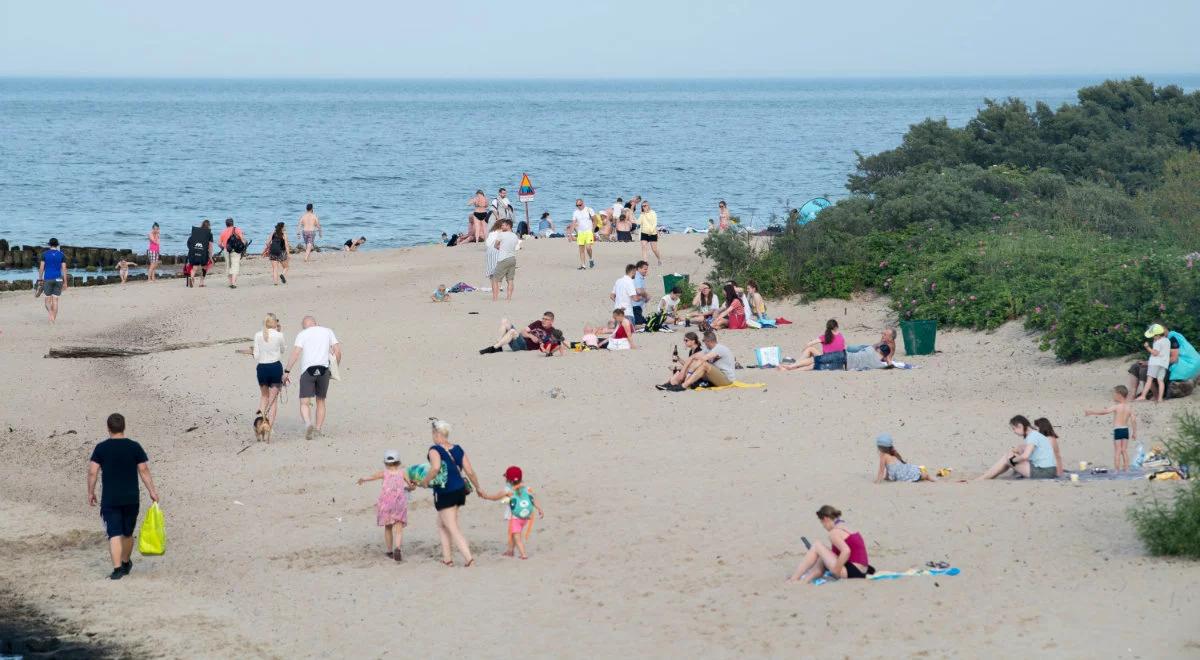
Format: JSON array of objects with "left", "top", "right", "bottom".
[{"left": 698, "top": 78, "right": 1200, "bottom": 360}]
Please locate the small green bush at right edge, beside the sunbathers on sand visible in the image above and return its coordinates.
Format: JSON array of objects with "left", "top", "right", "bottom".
[{"left": 1129, "top": 413, "right": 1200, "bottom": 559}]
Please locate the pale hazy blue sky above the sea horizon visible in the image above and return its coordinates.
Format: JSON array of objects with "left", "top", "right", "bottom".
[{"left": 0, "top": 0, "right": 1200, "bottom": 78}]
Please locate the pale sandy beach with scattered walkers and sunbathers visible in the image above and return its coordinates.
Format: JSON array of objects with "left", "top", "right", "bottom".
[{"left": 0, "top": 235, "right": 1200, "bottom": 658}]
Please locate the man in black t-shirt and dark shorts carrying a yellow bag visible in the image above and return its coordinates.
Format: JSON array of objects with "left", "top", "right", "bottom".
[{"left": 88, "top": 413, "right": 158, "bottom": 580}]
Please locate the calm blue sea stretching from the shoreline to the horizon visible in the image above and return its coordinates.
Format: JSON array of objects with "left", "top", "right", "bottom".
[{"left": 0, "top": 76, "right": 1200, "bottom": 252}]
